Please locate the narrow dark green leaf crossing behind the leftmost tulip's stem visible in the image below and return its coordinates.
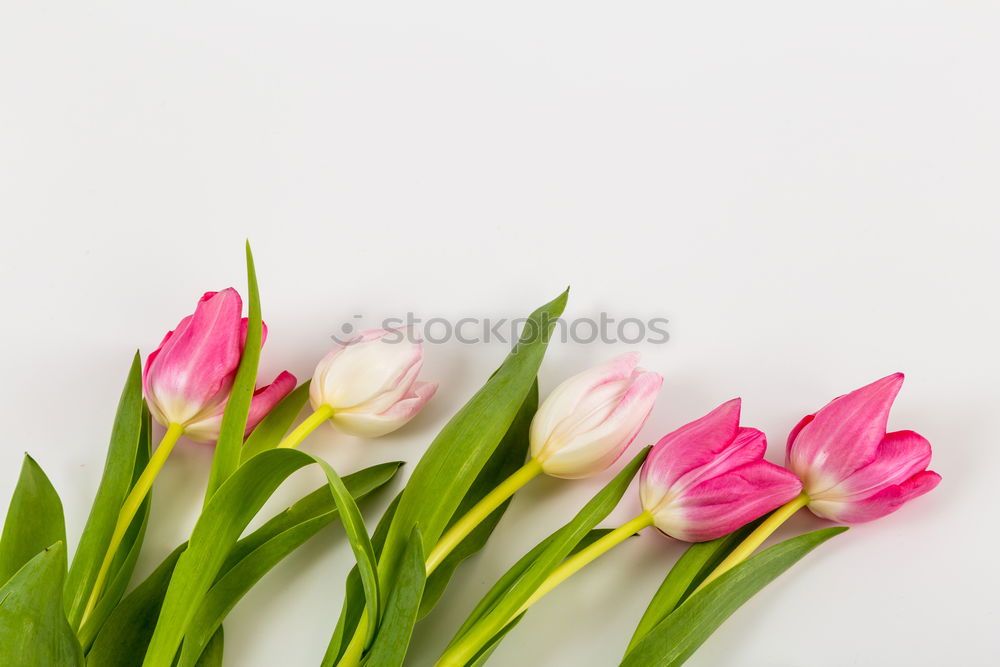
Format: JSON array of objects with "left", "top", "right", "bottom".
[{"left": 77, "top": 406, "right": 153, "bottom": 653}]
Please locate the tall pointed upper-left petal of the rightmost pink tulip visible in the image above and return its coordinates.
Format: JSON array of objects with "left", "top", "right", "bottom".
[{"left": 787, "top": 373, "right": 903, "bottom": 496}]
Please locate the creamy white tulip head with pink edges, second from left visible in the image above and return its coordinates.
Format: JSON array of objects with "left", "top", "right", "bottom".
[{"left": 309, "top": 329, "right": 437, "bottom": 438}]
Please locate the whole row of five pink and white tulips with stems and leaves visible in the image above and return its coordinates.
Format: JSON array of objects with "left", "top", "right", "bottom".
[{"left": 0, "top": 247, "right": 940, "bottom": 667}]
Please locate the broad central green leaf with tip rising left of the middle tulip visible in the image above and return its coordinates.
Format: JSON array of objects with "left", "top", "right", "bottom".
[{"left": 379, "top": 291, "right": 568, "bottom": 592}]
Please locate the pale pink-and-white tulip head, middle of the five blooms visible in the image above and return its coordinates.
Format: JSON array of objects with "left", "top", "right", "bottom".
[{"left": 529, "top": 352, "right": 663, "bottom": 478}]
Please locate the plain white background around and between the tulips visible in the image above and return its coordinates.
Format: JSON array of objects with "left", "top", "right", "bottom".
[{"left": 0, "top": 0, "right": 1000, "bottom": 667}]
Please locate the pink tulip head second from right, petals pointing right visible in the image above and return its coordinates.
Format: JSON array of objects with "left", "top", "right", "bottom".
[{"left": 639, "top": 398, "right": 802, "bottom": 542}]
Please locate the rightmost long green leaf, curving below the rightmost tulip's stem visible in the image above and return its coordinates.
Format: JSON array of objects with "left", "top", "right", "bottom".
[{"left": 621, "top": 526, "right": 847, "bottom": 667}]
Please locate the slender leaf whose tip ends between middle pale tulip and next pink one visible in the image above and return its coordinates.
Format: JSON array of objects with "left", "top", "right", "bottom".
[{"left": 446, "top": 447, "right": 650, "bottom": 664}]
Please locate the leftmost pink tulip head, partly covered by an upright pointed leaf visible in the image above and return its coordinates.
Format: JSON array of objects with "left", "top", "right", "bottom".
[{"left": 142, "top": 287, "right": 295, "bottom": 442}]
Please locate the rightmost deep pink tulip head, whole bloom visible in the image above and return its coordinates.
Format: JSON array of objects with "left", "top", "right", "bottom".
[{"left": 786, "top": 373, "right": 941, "bottom": 523}]
